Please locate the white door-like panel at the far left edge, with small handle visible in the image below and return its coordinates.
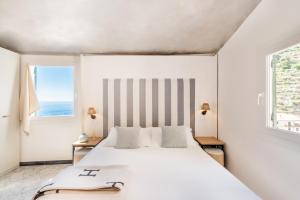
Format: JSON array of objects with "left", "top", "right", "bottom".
[{"left": 0, "top": 48, "right": 20, "bottom": 175}]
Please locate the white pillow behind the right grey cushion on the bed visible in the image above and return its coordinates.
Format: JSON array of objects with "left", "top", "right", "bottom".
[{"left": 152, "top": 127, "right": 199, "bottom": 147}]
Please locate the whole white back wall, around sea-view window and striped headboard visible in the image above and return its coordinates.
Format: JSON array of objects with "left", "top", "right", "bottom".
[{"left": 21, "top": 55, "right": 217, "bottom": 162}]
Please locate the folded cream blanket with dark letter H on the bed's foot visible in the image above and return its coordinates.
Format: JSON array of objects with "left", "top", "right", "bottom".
[{"left": 33, "top": 166, "right": 128, "bottom": 200}]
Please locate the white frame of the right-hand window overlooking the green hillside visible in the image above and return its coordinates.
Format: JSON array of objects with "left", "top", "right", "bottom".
[{"left": 265, "top": 42, "right": 300, "bottom": 136}]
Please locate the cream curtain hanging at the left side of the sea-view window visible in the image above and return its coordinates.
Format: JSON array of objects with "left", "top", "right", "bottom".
[{"left": 20, "top": 65, "right": 39, "bottom": 133}]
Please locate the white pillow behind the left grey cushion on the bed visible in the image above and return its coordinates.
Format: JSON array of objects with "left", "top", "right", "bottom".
[{"left": 101, "top": 127, "right": 152, "bottom": 147}]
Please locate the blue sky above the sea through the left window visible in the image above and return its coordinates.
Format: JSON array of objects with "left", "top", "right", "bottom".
[{"left": 36, "top": 66, "right": 74, "bottom": 102}]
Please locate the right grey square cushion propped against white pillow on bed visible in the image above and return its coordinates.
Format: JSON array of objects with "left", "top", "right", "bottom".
[{"left": 162, "top": 126, "right": 187, "bottom": 148}]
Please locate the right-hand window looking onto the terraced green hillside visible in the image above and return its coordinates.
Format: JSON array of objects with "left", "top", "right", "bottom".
[{"left": 268, "top": 44, "right": 300, "bottom": 133}]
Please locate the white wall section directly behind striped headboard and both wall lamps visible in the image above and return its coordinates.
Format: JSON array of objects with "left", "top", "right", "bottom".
[{"left": 81, "top": 56, "right": 217, "bottom": 136}]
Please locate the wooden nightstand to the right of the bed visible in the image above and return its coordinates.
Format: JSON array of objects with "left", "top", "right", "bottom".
[{"left": 195, "top": 137, "right": 225, "bottom": 166}]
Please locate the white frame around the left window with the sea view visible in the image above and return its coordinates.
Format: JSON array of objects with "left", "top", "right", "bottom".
[{"left": 31, "top": 64, "right": 78, "bottom": 121}]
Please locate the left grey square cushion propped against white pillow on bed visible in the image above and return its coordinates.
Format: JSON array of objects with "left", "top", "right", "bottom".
[{"left": 115, "top": 127, "right": 140, "bottom": 149}]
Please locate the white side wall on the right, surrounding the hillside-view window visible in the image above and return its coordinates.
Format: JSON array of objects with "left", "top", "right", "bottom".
[{"left": 219, "top": 0, "right": 300, "bottom": 200}]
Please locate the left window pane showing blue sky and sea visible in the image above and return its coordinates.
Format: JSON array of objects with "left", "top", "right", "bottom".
[{"left": 32, "top": 66, "right": 74, "bottom": 117}]
